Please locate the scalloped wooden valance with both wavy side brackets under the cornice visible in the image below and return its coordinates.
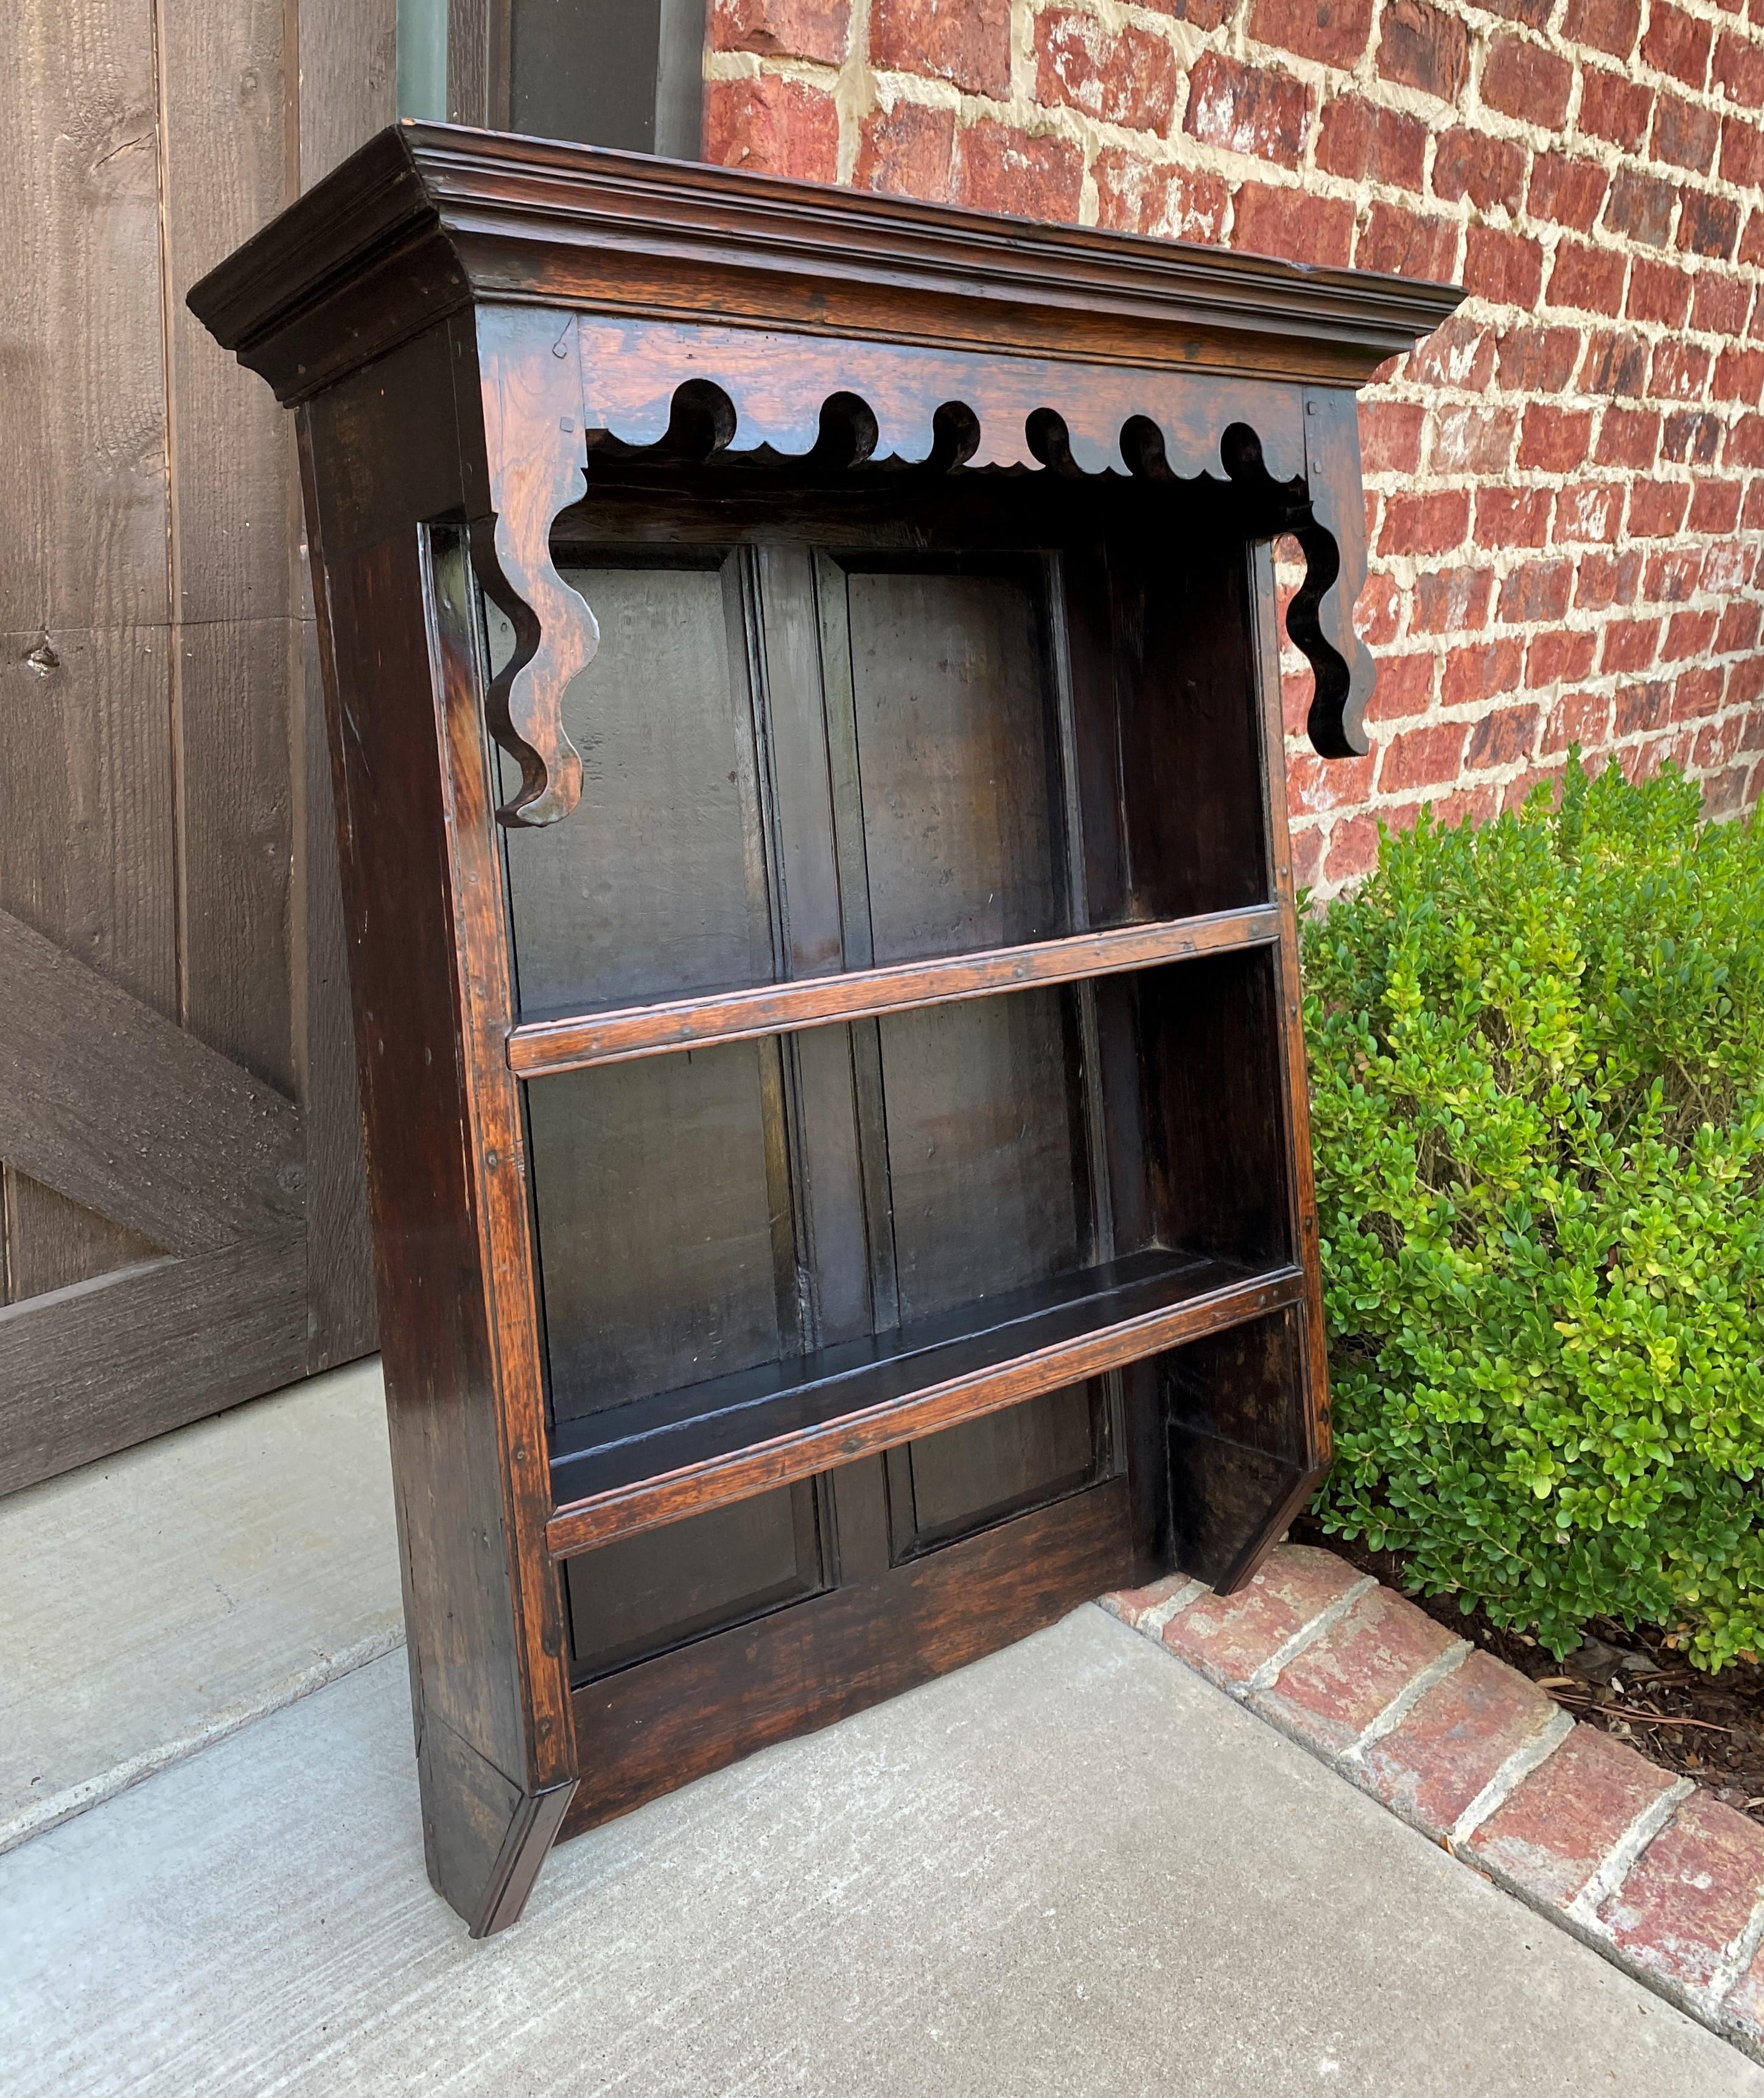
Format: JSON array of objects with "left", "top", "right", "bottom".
[{"left": 472, "top": 306, "right": 1372, "bottom": 827}]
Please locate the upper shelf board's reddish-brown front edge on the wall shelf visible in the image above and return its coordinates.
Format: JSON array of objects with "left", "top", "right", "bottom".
[{"left": 508, "top": 904, "right": 1279, "bottom": 1078}]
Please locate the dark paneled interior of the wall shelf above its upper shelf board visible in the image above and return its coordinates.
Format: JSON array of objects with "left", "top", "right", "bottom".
[{"left": 491, "top": 476, "right": 1271, "bottom": 1017}]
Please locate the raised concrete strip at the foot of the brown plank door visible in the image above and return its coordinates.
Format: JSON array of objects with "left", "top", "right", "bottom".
[{"left": 0, "top": 1359, "right": 405, "bottom": 1850}]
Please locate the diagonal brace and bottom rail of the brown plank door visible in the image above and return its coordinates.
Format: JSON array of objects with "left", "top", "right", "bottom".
[{"left": 0, "top": 911, "right": 309, "bottom": 1494}]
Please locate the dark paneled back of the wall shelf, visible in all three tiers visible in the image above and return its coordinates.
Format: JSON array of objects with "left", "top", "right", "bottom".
[{"left": 474, "top": 468, "right": 1292, "bottom": 1679}]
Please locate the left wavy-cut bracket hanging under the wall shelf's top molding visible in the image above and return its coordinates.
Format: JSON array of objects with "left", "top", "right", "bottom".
[{"left": 472, "top": 306, "right": 600, "bottom": 827}]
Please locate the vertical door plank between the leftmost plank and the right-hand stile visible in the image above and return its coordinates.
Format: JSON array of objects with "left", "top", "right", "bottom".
[{"left": 161, "top": 0, "right": 298, "bottom": 1093}]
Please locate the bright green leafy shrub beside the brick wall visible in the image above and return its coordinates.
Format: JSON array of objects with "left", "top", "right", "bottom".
[{"left": 1304, "top": 759, "right": 1764, "bottom": 1668}]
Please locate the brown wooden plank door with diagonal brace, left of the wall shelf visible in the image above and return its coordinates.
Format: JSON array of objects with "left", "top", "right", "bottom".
[{"left": 0, "top": 0, "right": 394, "bottom": 1492}]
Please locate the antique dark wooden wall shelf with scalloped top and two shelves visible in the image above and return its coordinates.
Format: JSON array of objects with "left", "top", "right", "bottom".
[{"left": 191, "top": 126, "right": 1458, "bottom": 1932}]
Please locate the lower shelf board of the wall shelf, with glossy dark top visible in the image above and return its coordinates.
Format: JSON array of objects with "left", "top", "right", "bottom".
[{"left": 545, "top": 1251, "right": 1303, "bottom": 1559}]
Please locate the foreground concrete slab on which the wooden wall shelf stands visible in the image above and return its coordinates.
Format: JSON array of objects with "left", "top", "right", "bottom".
[{"left": 0, "top": 1607, "right": 1764, "bottom": 2098}]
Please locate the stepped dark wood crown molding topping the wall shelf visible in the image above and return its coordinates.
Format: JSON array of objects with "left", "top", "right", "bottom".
[{"left": 189, "top": 124, "right": 1464, "bottom": 403}]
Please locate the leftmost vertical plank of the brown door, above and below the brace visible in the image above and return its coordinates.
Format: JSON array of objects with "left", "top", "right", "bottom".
[{"left": 0, "top": 0, "right": 176, "bottom": 1303}]
